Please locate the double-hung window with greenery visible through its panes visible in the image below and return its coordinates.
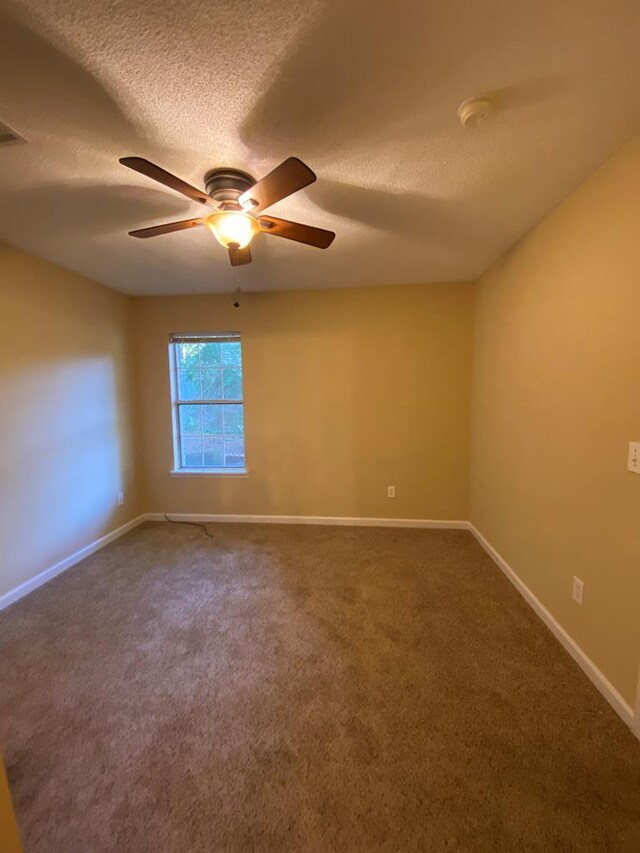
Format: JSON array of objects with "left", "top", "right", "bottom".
[{"left": 169, "top": 332, "right": 245, "bottom": 473}]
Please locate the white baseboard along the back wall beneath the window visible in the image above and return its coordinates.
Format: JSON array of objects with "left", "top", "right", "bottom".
[{"left": 145, "top": 512, "right": 469, "bottom": 530}]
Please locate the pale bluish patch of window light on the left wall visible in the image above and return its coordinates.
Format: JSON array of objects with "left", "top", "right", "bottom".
[{"left": 0, "top": 358, "right": 122, "bottom": 574}]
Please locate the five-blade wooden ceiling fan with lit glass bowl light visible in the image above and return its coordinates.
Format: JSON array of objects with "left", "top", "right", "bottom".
[{"left": 120, "top": 157, "right": 336, "bottom": 267}]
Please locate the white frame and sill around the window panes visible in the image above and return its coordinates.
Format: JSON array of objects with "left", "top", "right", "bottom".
[{"left": 169, "top": 332, "right": 249, "bottom": 477}]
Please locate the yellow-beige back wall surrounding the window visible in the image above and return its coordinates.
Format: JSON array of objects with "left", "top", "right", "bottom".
[{"left": 136, "top": 283, "right": 473, "bottom": 519}]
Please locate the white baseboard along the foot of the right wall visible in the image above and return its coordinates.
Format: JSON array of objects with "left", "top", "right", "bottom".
[{"left": 467, "top": 522, "right": 640, "bottom": 738}]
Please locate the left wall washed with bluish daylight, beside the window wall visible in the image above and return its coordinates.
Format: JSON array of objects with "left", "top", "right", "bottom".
[{"left": 0, "top": 245, "right": 139, "bottom": 595}]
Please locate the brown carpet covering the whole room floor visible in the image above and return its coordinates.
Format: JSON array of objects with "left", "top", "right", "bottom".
[{"left": 0, "top": 524, "right": 640, "bottom": 853}]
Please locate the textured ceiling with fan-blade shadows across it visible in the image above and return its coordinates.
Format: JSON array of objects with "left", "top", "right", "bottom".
[{"left": 0, "top": 0, "right": 640, "bottom": 294}]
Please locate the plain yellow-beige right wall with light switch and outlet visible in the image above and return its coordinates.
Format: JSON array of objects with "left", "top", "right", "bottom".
[{"left": 471, "top": 140, "right": 640, "bottom": 706}]
